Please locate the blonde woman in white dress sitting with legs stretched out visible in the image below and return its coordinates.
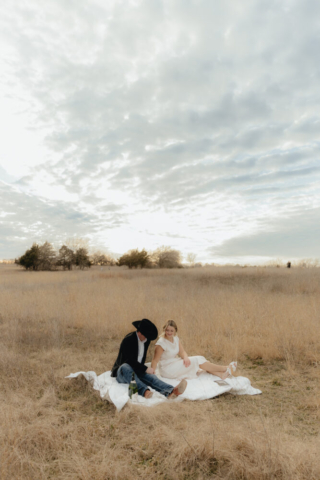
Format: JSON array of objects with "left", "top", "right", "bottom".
[{"left": 151, "top": 320, "right": 237, "bottom": 380}]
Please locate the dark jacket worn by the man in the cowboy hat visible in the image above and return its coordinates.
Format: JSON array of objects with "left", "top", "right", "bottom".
[{"left": 111, "top": 332, "right": 150, "bottom": 377}]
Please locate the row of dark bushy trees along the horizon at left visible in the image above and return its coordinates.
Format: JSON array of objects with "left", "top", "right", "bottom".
[{"left": 15, "top": 242, "right": 182, "bottom": 271}]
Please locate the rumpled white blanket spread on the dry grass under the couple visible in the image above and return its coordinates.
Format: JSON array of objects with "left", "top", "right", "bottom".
[{"left": 66, "top": 371, "right": 262, "bottom": 412}]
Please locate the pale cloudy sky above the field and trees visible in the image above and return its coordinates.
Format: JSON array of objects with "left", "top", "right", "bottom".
[{"left": 0, "top": 0, "right": 320, "bottom": 263}]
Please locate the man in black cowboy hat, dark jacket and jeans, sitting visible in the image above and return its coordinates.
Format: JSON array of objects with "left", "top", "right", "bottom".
[{"left": 111, "top": 318, "right": 187, "bottom": 399}]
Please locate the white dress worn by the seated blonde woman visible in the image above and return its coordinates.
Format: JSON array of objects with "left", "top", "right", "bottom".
[{"left": 156, "top": 335, "right": 207, "bottom": 380}]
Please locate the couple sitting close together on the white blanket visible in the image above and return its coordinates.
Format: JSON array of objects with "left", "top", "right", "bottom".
[{"left": 111, "top": 318, "right": 237, "bottom": 399}]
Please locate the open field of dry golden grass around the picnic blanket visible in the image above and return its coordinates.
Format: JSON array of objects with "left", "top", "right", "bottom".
[{"left": 0, "top": 265, "right": 320, "bottom": 480}]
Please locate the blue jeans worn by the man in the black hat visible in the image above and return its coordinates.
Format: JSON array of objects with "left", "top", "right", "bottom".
[{"left": 117, "top": 363, "right": 173, "bottom": 397}]
